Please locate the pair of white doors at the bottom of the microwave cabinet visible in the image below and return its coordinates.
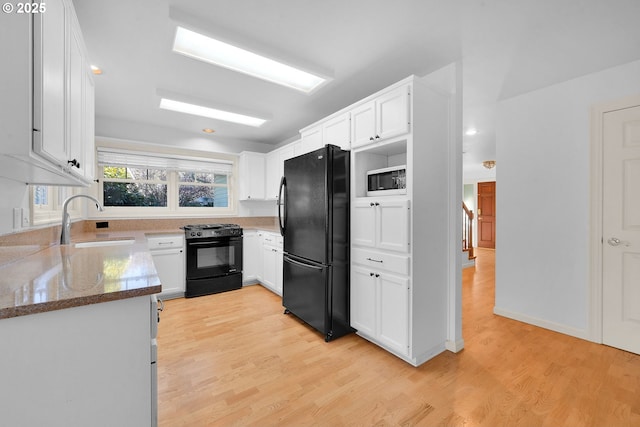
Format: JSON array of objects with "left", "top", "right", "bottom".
[{"left": 351, "top": 265, "right": 409, "bottom": 357}]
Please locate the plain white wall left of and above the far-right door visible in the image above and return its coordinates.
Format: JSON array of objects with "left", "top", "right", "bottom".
[{"left": 495, "top": 61, "right": 640, "bottom": 338}]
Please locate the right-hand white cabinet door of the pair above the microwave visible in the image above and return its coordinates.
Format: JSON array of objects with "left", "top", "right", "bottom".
[{"left": 376, "top": 86, "right": 409, "bottom": 139}]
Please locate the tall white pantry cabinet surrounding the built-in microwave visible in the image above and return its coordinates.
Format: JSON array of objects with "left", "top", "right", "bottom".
[{"left": 348, "top": 76, "right": 451, "bottom": 366}]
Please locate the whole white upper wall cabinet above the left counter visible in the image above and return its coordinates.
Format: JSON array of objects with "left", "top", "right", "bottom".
[{"left": 0, "top": 0, "right": 95, "bottom": 186}]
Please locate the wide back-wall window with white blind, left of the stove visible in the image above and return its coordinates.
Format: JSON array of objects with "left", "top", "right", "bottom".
[{"left": 98, "top": 147, "right": 233, "bottom": 215}]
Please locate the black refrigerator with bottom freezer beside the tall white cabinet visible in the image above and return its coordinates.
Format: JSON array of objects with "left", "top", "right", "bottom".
[{"left": 278, "top": 145, "right": 353, "bottom": 342}]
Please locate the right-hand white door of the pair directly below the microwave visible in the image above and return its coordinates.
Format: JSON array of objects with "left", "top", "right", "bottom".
[{"left": 374, "top": 199, "right": 410, "bottom": 252}]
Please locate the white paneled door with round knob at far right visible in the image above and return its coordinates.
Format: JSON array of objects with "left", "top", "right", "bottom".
[{"left": 602, "top": 106, "right": 640, "bottom": 354}]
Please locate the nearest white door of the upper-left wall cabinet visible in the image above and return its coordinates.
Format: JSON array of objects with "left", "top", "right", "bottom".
[{"left": 33, "top": 0, "right": 69, "bottom": 166}]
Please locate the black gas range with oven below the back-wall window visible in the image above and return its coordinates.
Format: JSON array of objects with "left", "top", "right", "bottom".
[{"left": 183, "top": 224, "right": 242, "bottom": 298}]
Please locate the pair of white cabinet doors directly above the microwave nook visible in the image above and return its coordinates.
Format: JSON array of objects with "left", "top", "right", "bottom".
[{"left": 351, "top": 86, "right": 410, "bottom": 148}]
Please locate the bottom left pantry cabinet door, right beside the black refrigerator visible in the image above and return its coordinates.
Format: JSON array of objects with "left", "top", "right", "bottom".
[{"left": 350, "top": 265, "right": 377, "bottom": 338}]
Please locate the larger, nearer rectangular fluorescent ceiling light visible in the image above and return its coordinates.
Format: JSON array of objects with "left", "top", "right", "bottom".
[{"left": 173, "top": 26, "right": 327, "bottom": 93}]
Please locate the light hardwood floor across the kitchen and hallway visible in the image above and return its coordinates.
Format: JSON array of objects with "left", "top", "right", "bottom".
[{"left": 158, "top": 249, "right": 640, "bottom": 427}]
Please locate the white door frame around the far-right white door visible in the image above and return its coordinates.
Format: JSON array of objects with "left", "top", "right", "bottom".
[{"left": 588, "top": 95, "right": 640, "bottom": 344}]
